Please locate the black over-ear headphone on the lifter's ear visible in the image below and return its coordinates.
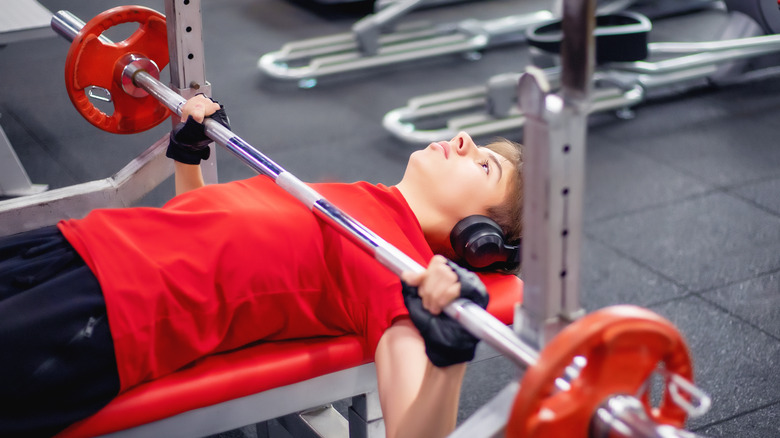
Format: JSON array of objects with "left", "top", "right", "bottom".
[{"left": 450, "top": 215, "right": 522, "bottom": 271}]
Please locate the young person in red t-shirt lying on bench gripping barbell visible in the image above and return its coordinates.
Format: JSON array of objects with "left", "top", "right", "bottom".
[{"left": 0, "top": 96, "right": 522, "bottom": 438}]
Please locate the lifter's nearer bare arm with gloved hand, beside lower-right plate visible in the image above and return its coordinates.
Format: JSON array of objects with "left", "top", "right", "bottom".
[{"left": 384, "top": 257, "right": 488, "bottom": 438}]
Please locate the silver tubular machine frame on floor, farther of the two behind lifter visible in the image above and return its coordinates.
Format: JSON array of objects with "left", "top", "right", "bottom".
[{"left": 257, "top": 0, "right": 553, "bottom": 88}]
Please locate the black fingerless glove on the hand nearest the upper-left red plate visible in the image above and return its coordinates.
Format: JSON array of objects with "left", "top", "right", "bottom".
[{"left": 165, "top": 99, "right": 230, "bottom": 164}]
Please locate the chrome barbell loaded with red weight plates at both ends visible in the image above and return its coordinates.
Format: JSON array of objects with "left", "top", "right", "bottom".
[{"left": 52, "top": 6, "right": 709, "bottom": 437}]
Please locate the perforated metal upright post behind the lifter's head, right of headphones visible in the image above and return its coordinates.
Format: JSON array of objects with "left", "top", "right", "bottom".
[{"left": 515, "top": 0, "right": 595, "bottom": 350}]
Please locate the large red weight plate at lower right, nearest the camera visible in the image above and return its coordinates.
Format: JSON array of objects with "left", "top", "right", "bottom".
[{"left": 507, "top": 306, "right": 693, "bottom": 438}]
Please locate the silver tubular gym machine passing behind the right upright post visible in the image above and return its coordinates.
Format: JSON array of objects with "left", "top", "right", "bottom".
[{"left": 383, "top": 0, "right": 780, "bottom": 144}]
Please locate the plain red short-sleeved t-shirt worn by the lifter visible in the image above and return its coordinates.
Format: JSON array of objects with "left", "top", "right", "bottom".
[{"left": 59, "top": 176, "right": 433, "bottom": 390}]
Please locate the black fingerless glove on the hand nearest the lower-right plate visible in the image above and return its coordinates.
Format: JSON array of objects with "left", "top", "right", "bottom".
[{"left": 401, "top": 260, "right": 490, "bottom": 367}]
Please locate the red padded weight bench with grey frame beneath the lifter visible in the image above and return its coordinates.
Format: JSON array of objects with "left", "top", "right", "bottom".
[{"left": 57, "top": 274, "right": 522, "bottom": 438}]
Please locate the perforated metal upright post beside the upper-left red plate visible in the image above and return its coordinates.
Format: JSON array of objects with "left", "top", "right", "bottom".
[{"left": 165, "top": 0, "right": 217, "bottom": 184}]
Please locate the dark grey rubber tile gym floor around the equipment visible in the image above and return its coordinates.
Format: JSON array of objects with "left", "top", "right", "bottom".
[{"left": 0, "top": 0, "right": 780, "bottom": 438}]
